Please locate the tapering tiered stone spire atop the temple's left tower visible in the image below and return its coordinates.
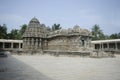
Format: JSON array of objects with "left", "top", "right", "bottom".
[{"left": 23, "top": 17, "right": 45, "bottom": 37}]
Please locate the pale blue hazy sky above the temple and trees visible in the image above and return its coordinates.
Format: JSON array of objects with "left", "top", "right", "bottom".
[{"left": 0, "top": 0, "right": 120, "bottom": 35}]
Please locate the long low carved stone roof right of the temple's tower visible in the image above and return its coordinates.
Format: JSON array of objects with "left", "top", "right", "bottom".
[{"left": 47, "top": 25, "right": 92, "bottom": 38}]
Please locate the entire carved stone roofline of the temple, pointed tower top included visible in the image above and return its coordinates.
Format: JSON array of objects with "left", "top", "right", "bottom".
[{"left": 23, "top": 17, "right": 92, "bottom": 38}]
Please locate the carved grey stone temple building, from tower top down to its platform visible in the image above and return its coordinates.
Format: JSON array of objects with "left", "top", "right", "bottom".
[{"left": 23, "top": 17, "right": 92, "bottom": 52}]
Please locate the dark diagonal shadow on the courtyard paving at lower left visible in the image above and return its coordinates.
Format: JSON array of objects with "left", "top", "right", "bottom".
[{"left": 0, "top": 55, "right": 53, "bottom": 80}]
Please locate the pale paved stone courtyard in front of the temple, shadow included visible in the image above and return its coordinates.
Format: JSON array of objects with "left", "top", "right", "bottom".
[{"left": 0, "top": 55, "right": 120, "bottom": 80}]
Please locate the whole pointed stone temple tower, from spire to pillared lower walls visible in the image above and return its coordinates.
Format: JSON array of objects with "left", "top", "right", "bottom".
[{"left": 23, "top": 17, "right": 44, "bottom": 50}]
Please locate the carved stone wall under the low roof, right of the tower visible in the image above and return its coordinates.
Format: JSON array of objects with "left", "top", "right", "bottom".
[{"left": 47, "top": 36, "right": 91, "bottom": 51}]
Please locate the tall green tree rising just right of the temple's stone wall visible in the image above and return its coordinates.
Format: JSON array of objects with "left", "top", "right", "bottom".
[{"left": 92, "top": 24, "right": 105, "bottom": 40}]
